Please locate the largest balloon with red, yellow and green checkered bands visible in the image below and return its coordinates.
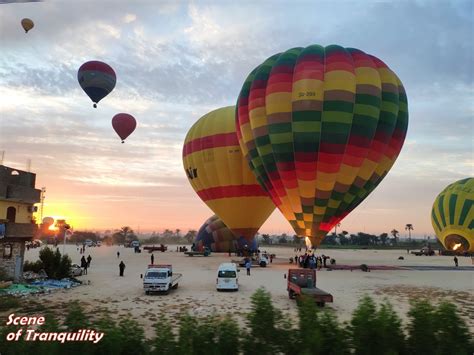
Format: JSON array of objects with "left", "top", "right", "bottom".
[{"left": 236, "top": 45, "right": 408, "bottom": 246}]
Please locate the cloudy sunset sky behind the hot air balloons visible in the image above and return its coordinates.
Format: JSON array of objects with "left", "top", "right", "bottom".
[{"left": 0, "top": 0, "right": 474, "bottom": 236}]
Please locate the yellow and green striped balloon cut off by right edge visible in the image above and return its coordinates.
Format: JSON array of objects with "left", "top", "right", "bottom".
[{"left": 431, "top": 178, "right": 474, "bottom": 253}]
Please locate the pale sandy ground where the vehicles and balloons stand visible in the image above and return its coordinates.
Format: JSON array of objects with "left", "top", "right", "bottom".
[{"left": 15, "top": 245, "right": 474, "bottom": 335}]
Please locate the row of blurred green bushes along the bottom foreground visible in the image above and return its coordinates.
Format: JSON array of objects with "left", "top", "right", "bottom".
[{"left": 0, "top": 289, "right": 474, "bottom": 355}]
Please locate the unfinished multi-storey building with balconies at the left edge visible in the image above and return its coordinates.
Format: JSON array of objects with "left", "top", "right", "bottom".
[{"left": 0, "top": 165, "right": 41, "bottom": 281}]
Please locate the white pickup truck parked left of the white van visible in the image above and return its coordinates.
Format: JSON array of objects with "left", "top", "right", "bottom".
[{"left": 143, "top": 265, "right": 182, "bottom": 295}]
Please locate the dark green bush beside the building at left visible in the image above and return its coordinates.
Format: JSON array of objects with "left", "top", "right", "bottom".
[{"left": 23, "top": 247, "right": 72, "bottom": 280}]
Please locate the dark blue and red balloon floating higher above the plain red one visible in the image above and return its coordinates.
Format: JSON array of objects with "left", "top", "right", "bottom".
[{"left": 77, "top": 60, "right": 117, "bottom": 107}]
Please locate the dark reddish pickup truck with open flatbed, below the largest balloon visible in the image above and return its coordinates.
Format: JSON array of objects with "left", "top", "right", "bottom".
[{"left": 287, "top": 269, "right": 333, "bottom": 307}]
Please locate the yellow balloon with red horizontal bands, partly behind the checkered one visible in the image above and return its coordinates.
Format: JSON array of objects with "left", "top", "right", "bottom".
[{"left": 183, "top": 106, "right": 275, "bottom": 243}]
